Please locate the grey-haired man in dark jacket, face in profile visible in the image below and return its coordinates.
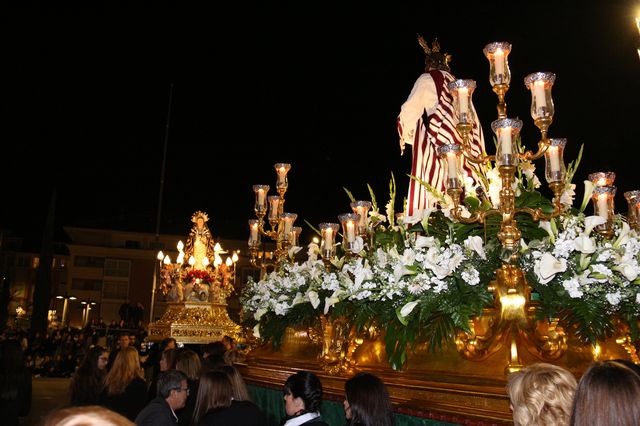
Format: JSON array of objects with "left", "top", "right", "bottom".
[{"left": 136, "top": 370, "right": 189, "bottom": 426}]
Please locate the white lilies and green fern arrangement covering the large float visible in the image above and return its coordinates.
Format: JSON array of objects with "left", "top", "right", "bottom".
[{"left": 241, "top": 144, "right": 640, "bottom": 369}]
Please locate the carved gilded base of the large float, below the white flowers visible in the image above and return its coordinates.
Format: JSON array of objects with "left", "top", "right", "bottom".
[{"left": 240, "top": 321, "right": 635, "bottom": 425}]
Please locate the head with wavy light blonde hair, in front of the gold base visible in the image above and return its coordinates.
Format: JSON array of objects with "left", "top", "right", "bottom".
[{"left": 507, "top": 362, "right": 577, "bottom": 426}]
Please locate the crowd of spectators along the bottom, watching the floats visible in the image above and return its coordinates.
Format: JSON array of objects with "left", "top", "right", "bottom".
[{"left": 0, "top": 322, "right": 640, "bottom": 426}]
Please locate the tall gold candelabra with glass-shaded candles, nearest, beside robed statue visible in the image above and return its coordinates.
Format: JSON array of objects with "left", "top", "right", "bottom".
[{"left": 438, "top": 42, "right": 567, "bottom": 371}]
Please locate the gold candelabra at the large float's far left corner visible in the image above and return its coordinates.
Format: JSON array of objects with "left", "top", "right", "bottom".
[{"left": 249, "top": 163, "right": 302, "bottom": 277}]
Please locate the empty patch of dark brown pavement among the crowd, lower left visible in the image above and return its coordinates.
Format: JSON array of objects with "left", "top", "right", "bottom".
[{"left": 21, "top": 377, "right": 70, "bottom": 426}]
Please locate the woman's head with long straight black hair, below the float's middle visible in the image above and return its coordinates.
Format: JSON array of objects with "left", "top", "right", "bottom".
[{"left": 344, "top": 373, "right": 395, "bottom": 426}]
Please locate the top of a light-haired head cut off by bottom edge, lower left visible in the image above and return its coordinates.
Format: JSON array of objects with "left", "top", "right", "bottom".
[{"left": 43, "top": 405, "right": 135, "bottom": 426}]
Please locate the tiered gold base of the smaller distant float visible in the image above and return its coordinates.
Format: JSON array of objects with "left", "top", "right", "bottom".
[{"left": 147, "top": 302, "right": 242, "bottom": 344}]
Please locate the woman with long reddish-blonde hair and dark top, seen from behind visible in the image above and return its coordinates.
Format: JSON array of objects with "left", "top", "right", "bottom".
[{"left": 100, "top": 346, "right": 147, "bottom": 421}]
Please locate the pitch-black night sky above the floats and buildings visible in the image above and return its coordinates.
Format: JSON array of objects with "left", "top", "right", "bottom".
[{"left": 0, "top": 0, "right": 640, "bottom": 246}]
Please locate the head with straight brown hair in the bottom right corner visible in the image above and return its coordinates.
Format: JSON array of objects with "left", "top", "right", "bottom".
[{"left": 570, "top": 361, "right": 640, "bottom": 426}]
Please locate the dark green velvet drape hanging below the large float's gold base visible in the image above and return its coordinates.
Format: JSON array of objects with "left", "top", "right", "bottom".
[{"left": 247, "top": 385, "right": 452, "bottom": 426}]
